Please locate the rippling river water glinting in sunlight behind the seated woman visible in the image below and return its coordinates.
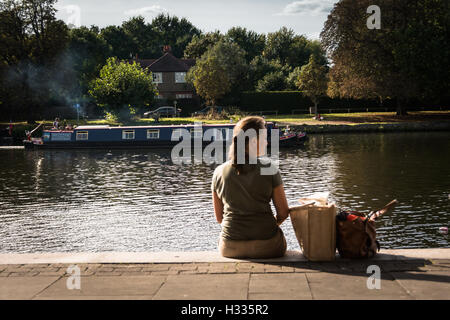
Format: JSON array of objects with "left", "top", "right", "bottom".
[{"left": 0, "top": 132, "right": 450, "bottom": 252}]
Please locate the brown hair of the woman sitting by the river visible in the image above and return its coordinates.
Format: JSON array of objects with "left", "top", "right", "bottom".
[{"left": 229, "top": 116, "right": 266, "bottom": 174}]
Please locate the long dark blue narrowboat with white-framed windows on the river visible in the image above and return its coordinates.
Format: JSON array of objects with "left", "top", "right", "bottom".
[{"left": 24, "top": 122, "right": 302, "bottom": 149}]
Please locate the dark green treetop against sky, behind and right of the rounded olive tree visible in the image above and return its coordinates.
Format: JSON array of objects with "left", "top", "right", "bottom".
[{"left": 225, "top": 27, "right": 266, "bottom": 63}]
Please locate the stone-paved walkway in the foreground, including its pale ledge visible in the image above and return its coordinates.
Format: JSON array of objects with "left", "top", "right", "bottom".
[{"left": 0, "top": 249, "right": 450, "bottom": 300}]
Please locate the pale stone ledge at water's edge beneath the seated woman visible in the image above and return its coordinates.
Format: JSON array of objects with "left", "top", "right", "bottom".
[{"left": 0, "top": 248, "right": 450, "bottom": 265}]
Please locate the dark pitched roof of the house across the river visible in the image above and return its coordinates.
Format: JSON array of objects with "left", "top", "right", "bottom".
[{"left": 129, "top": 52, "right": 195, "bottom": 72}]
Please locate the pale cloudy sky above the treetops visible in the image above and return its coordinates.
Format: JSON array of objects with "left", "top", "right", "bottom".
[{"left": 57, "top": 0, "right": 336, "bottom": 39}]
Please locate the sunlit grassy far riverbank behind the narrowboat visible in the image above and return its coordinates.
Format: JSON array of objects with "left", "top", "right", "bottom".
[{"left": 0, "top": 111, "right": 450, "bottom": 145}]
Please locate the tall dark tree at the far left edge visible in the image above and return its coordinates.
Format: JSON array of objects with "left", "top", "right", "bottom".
[{"left": 0, "top": 0, "right": 68, "bottom": 122}]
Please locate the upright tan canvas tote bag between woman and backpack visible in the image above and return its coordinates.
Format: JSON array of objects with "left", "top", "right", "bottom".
[{"left": 290, "top": 201, "right": 336, "bottom": 261}]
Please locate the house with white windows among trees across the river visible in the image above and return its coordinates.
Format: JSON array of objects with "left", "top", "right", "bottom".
[{"left": 132, "top": 47, "right": 196, "bottom": 100}]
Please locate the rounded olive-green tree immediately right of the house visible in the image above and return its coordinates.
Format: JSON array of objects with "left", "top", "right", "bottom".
[{"left": 187, "top": 54, "right": 232, "bottom": 106}]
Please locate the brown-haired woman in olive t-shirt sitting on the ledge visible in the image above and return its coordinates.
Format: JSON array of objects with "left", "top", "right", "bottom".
[{"left": 211, "top": 117, "right": 289, "bottom": 259}]
